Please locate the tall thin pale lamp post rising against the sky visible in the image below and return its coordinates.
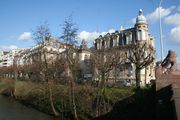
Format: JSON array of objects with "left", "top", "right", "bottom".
[{"left": 159, "top": 0, "right": 164, "bottom": 62}]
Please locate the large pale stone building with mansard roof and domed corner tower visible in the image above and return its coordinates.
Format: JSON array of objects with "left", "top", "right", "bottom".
[{"left": 94, "top": 9, "right": 155, "bottom": 85}]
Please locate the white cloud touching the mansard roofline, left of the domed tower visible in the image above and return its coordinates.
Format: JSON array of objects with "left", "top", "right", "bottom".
[{"left": 78, "top": 29, "right": 115, "bottom": 42}]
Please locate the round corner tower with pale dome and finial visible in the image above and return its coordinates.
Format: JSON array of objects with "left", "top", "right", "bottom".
[{"left": 135, "top": 9, "right": 149, "bottom": 41}]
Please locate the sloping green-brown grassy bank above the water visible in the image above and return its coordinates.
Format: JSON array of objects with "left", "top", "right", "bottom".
[{"left": 0, "top": 79, "right": 134, "bottom": 119}]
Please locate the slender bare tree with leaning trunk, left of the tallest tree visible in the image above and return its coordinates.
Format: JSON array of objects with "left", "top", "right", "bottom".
[{"left": 33, "top": 22, "right": 60, "bottom": 116}]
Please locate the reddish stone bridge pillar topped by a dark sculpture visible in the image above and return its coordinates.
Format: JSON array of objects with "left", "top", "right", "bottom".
[{"left": 156, "top": 50, "right": 180, "bottom": 120}]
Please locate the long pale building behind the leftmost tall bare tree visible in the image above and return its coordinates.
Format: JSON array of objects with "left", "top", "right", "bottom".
[{"left": 14, "top": 38, "right": 66, "bottom": 65}]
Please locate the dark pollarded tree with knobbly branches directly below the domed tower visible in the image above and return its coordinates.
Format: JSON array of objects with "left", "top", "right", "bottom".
[{"left": 127, "top": 42, "right": 155, "bottom": 88}]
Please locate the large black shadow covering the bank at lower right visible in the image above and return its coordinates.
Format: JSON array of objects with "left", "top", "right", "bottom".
[{"left": 94, "top": 85, "right": 176, "bottom": 120}]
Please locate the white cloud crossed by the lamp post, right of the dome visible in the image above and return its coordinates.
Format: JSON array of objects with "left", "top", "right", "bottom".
[{"left": 146, "top": 6, "right": 176, "bottom": 22}]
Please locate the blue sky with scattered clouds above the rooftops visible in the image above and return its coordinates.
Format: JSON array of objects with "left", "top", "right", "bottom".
[{"left": 0, "top": 0, "right": 180, "bottom": 65}]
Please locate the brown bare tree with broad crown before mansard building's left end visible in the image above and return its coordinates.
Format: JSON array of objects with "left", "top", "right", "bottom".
[{"left": 91, "top": 48, "right": 124, "bottom": 116}]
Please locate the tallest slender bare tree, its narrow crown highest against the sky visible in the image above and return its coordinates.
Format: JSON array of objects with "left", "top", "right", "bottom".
[{"left": 60, "top": 16, "right": 78, "bottom": 120}]
